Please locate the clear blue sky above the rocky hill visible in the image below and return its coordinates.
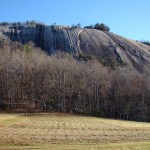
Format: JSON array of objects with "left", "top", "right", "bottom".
[{"left": 0, "top": 0, "right": 150, "bottom": 41}]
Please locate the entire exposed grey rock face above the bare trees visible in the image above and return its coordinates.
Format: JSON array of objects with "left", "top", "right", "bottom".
[{"left": 0, "top": 24, "right": 150, "bottom": 72}]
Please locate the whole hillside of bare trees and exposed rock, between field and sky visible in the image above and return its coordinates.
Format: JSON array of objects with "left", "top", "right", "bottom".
[{"left": 0, "top": 24, "right": 150, "bottom": 121}]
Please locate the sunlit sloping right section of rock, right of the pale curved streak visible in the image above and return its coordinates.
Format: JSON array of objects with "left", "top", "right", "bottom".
[{"left": 80, "top": 29, "right": 150, "bottom": 72}]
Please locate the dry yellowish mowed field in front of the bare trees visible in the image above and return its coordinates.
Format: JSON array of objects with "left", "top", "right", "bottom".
[{"left": 0, "top": 113, "right": 150, "bottom": 150}]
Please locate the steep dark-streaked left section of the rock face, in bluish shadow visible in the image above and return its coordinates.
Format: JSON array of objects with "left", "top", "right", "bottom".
[{"left": 0, "top": 25, "right": 81, "bottom": 55}]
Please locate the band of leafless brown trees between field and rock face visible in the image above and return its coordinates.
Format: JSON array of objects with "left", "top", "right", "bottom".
[{"left": 0, "top": 43, "right": 150, "bottom": 121}]
